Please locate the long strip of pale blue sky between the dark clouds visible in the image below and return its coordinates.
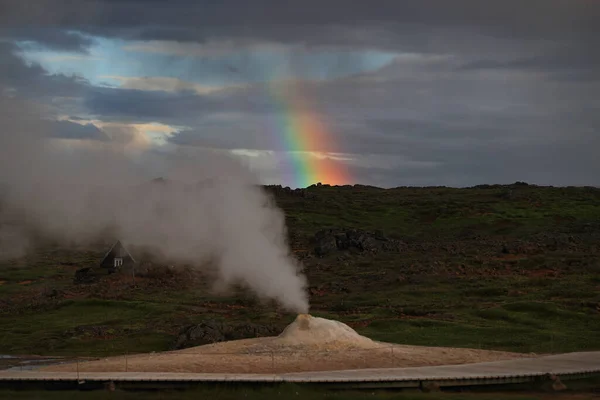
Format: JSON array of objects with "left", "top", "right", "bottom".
[{"left": 16, "top": 38, "right": 396, "bottom": 86}]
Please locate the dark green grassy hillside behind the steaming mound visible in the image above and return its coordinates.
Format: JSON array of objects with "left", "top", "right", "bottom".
[{"left": 0, "top": 185, "right": 600, "bottom": 355}]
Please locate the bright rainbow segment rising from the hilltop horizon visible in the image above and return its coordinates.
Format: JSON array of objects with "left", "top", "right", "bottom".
[{"left": 269, "top": 81, "right": 350, "bottom": 188}]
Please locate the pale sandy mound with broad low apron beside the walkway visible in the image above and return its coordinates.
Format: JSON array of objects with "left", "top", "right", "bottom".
[{"left": 45, "top": 314, "right": 531, "bottom": 373}]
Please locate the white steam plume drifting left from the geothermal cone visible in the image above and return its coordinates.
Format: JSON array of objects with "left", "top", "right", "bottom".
[{"left": 0, "top": 95, "right": 308, "bottom": 313}]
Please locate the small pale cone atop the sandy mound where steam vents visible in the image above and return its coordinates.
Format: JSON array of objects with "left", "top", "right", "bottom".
[{"left": 277, "top": 314, "right": 378, "bottom": 347}]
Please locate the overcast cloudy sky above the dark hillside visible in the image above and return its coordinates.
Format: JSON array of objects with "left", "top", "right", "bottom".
[{"left": 0, "top": 0, "right": 600, "bottom": 187}]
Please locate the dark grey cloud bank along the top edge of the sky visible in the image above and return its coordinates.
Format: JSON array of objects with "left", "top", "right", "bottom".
[{"left": 0, "top": 0, "right": 600, "bottom": 90}]
